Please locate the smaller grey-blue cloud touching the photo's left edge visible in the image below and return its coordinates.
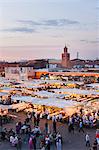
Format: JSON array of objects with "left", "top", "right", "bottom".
[{"left": 1, "top": 27, "right": 35, "bottom": 33}]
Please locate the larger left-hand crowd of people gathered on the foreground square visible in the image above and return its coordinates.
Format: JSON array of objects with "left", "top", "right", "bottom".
[{"left": 1, "top": 110, "right": 62, "bottom": 150}]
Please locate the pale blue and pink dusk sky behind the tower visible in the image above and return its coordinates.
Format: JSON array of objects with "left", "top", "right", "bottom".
[{"left": 0, "top": 0, "right": 99, "bottom": 61}]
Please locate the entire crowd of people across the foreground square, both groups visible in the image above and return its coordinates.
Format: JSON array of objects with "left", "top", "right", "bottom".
[{"left": 1, "top": 109, "right": 99, "bottom": 150}]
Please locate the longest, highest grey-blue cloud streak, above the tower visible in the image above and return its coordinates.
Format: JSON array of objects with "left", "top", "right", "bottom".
[{"left": 18, "top": 19, "right": 80, "bottom": 27}]
